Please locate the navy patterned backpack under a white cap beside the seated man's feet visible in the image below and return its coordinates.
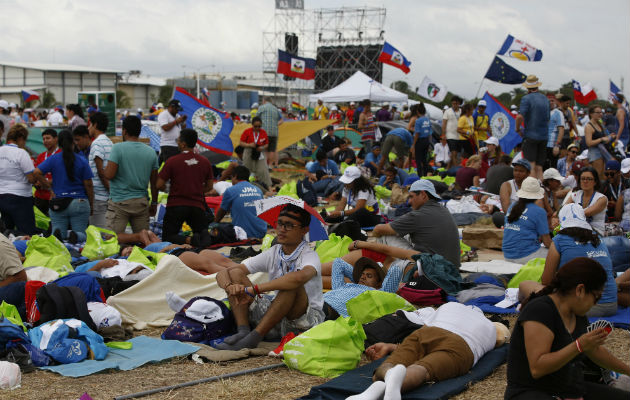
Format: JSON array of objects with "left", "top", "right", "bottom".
[{"left": 162, "top": 296, "right": 236, "bottom": 344}]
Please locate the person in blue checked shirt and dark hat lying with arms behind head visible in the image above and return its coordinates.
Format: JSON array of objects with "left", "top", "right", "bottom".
[{"left": 324, "top": 257, "right": 402, "bottom": 319}]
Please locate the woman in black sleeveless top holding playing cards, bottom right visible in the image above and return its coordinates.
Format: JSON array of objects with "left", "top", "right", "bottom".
[{"left": 504, "top": 257, "right": 630, "bottom": 400}]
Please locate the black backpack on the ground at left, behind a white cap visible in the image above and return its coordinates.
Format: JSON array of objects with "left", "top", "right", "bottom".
[{"left": 35, "top": 283, "right": 96, "bottom": 332}]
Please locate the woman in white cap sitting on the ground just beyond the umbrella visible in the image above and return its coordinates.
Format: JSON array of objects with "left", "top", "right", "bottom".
[{"left": 326, "top": 166, "right": 381, "bottom": 227}]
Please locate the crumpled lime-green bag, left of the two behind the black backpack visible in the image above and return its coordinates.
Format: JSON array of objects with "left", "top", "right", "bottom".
[{"left": 24, "top": 235, "right": 74, "bottom": 276}]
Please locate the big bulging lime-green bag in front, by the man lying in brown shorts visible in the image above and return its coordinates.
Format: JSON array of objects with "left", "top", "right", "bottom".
[{"left": 283, "top": 317, "right": 365, "bottom": 378}]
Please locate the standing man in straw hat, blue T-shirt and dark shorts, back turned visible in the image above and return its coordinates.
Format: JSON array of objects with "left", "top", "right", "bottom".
[{"left": 516, "top": 75, "right": 549, "bottom": 179}]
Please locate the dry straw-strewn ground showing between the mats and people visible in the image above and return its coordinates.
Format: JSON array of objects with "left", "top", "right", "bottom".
[{"left": 6, "top": 166, "right": 630, "bottom": 400}]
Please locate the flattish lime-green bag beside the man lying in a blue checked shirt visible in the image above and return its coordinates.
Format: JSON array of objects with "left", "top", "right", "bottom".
[{"left": 346, "top": 290, "right": 416, "bottom": 324}]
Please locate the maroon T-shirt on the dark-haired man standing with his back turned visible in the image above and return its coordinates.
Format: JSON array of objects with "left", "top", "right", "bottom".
[{"left": 158, "top": 151, "right": 213, "bottom": 210}]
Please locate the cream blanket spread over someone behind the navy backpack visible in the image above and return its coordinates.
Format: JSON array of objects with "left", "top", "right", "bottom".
[{"left": 107, "top": 255, "right": 268, "bottom": 330}]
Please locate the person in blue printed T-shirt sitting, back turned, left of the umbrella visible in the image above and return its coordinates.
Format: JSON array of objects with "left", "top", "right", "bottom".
[{"left": 215, "top": 165, "right": 267, "bottom": 239}]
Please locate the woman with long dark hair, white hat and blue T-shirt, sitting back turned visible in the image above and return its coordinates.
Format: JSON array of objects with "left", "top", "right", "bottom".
[{"left": 503, "top": 176, "right": 551, "bottom": 264}]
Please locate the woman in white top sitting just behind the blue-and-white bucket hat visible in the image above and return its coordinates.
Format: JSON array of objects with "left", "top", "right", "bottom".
[{"left": 566, "top": 167, "right": 608, "bottom": 236}]
